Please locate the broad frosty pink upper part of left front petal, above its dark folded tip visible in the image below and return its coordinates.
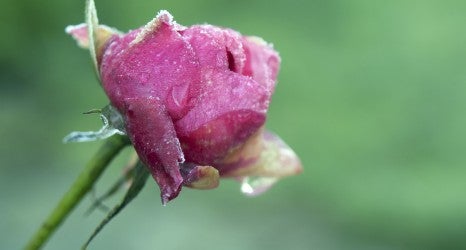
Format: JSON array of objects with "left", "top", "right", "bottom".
[{"left": 100, "top": 12, "right": 200, "bottom": 120}]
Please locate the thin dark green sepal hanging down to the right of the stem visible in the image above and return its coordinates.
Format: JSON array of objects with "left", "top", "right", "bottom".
[{"left": 82, "top": 161, "right": 149, "bottom": 249}]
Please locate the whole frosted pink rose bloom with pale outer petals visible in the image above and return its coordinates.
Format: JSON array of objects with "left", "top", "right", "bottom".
[{"left": 67, "top": 4, "right": 301, "bottom": 204}]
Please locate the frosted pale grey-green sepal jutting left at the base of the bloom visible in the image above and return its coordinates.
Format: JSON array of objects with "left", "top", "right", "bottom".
[{"left": 63, "top": 105, "right": 126, "bottom": 143}]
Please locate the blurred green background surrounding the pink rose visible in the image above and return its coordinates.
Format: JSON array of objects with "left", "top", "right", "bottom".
[{"left": 0, "top": 0, "right": 466, "bottom": 250}]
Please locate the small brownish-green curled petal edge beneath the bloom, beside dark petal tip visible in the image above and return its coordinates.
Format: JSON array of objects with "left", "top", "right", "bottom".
[{"left": 181, "top": 162, "right": 220, "bottom": 189}]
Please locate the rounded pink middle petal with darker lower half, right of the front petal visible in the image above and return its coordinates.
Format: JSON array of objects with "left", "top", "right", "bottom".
[{"left": 176, "top": 71, "right": 270, "bottom": 165}]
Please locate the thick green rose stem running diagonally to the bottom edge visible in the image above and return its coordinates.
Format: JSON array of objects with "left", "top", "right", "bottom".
[{"left": 24, "top": 135, "right": 129, "bottom": 250}]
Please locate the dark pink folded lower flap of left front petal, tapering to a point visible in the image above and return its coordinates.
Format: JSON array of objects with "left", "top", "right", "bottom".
[{"left": 123, "top": 98, "right": 184, "bottom": 204}]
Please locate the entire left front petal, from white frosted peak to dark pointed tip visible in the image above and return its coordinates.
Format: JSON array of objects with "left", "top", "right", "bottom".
[{"left": 100, "top": 12, "right": 200, "bottom": 204}]
